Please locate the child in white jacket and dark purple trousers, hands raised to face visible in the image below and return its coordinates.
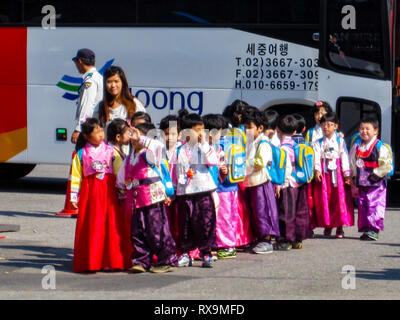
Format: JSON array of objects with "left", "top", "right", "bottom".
[{"left": 171, "top": 113, "right": 219, "bottom": 268}]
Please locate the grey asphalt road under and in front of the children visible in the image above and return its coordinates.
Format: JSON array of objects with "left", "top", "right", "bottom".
[{"left": 0, "top": 165, "right": 400, "bottom": 300}]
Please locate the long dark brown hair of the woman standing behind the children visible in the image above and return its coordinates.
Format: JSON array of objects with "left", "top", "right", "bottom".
[{"left": 99, "top": 66, "right": 136, "bottom": 124}]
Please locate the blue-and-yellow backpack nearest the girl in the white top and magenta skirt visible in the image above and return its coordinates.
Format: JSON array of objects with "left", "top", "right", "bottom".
[{"left": 286, "top": 143, "right": 314, "bottom": 184}]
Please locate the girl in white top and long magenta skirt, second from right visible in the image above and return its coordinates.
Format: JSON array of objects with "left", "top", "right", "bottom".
[{"left": 313, "top": 112, "right": 354, "bottom": 238}]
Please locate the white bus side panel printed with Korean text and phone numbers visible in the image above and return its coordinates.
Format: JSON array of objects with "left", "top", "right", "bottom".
[{"left": 14, "top": 27, "right": 318, "bottom": 164}]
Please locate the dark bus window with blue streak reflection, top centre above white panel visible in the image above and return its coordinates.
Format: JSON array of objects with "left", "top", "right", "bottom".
[{"left": 137, "top": 0, "right": 258, "bottom": 25}]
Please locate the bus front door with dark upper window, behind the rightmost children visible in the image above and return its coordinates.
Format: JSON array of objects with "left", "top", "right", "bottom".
[{"left": 318, "top": 0, "right": 392, "bottom": 148}]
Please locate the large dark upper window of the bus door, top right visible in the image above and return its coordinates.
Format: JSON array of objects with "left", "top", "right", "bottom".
[{"left": 326, "top": 0, "right": 384, "bottom": 78}]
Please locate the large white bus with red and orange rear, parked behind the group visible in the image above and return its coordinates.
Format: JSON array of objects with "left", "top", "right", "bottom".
[{"left": 0, "top": 0, "right": 400, "bottom": 178}]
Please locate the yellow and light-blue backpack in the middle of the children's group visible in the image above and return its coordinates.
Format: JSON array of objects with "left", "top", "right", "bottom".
[{"left": 222, "top": 128, "right": 246, "bottom": 185}]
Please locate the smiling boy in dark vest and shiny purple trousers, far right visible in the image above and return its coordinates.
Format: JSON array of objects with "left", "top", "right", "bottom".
[{"left": 350, "top": 118, "right": 393, "bottom": 241}]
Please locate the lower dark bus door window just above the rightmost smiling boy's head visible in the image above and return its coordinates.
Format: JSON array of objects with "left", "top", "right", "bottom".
[{"left": 336, "top": 97, "right": 381, "bottom": 141}]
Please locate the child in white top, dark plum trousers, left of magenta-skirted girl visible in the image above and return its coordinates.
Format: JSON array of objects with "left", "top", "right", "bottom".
[{"left": 274, "top": 115, "right": 310, "bottom": 250}]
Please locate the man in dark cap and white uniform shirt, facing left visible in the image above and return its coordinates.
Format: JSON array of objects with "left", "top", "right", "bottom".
[{"left": 71, "top": 48, "right": 103, "bottom": 143}]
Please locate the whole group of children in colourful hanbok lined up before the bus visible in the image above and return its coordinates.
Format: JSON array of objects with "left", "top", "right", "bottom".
[{"left": 71, "top": 100, "right": 392, "bottom": 273}]
